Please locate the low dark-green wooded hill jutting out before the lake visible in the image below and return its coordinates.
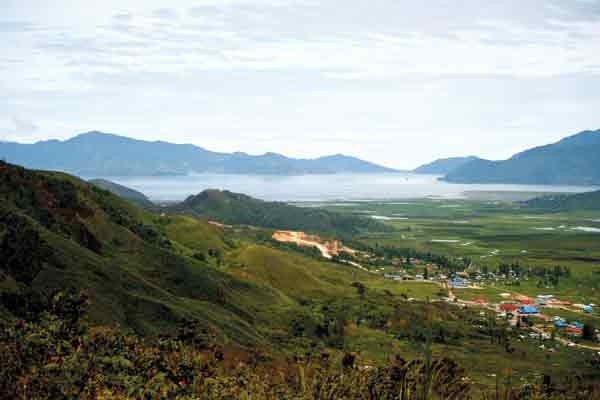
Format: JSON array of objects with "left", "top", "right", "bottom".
[{"left": 170, "top": 189, "right": 389, "bottom": 236}]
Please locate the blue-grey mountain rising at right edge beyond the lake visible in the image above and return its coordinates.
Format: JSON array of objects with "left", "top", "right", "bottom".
[{"left": 444, "top": 130, "right": 600, "bottom": 185}]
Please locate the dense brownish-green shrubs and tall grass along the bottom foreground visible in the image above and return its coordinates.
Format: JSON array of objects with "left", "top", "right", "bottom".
[{"left": 0, "top": 292, "right": 600, "bottom": 400}]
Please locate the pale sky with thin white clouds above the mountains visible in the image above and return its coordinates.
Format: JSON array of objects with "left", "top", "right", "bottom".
[{"left": 0, "top": 0, "right": 600, "bottom": 169}]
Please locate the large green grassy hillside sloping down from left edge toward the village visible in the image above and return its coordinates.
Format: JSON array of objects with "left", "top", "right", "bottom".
[{"left": 0, "top": 162, "right": 392, "bottom": 351}]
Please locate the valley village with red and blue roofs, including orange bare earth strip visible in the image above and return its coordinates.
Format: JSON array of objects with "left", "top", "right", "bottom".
[{"left": 273, "top": 231, "right": 600, "bottom": 355}]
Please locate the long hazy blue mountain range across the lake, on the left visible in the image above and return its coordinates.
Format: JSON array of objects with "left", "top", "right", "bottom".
[{"left": 0, "top": 132, "right": 395, "bottom": 176}]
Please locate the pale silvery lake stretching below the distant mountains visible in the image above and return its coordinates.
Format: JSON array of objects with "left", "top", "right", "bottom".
[{"left": 96, "top": 173, "right": 596, "bottom": 201}]
